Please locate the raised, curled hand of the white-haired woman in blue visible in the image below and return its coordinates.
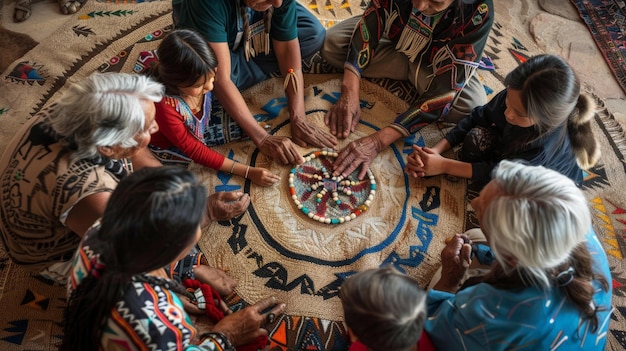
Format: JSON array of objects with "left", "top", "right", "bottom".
[{"left": 434, "top": 234, "right": 472, "bottom": 293}]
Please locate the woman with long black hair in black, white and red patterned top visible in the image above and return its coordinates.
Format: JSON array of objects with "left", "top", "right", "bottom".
[{"left": 61, "top": 166, "right": 284, "bottom": 350}]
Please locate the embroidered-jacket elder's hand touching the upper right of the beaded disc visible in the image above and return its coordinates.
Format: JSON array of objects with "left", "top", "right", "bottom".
[{"left": 333, "top": 134, "right": 382, "bottom": 179}]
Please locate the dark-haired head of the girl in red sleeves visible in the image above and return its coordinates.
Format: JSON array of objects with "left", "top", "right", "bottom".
[{"left": 154, "top": 29, "right": 217, "bottom": 96}]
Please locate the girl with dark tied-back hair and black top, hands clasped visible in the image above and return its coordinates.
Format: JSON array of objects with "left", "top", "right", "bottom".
[{"left": 405, "top": 55, "right": 600, "bottom": 187}]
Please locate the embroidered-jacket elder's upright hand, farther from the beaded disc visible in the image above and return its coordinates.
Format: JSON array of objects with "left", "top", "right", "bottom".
[{"left": 324, "top": 90, "right": 361, "bottom": 139}]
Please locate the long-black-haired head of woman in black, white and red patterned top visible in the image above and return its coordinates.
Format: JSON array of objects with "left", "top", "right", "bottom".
[{"left": 95, "top": 166, "right": 207, "bottom": 276}]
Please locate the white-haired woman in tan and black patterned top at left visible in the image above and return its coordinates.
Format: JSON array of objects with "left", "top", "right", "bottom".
[{"left": 0, "top": 73, "right": 249, "bottom": 281}]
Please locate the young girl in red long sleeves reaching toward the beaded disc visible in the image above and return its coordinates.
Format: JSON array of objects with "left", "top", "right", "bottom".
[{"left": 150, "top": 29, "right": 280, "bottom": 186}]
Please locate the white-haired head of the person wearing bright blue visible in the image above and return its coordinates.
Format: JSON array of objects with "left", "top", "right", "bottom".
[{"left": 472, "top": 160, "right": 591, "bottom": 288}]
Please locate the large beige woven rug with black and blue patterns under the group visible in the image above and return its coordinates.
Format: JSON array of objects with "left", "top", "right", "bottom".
[{"left": 0, "top": 0, "right": 626, "bottom": 350}]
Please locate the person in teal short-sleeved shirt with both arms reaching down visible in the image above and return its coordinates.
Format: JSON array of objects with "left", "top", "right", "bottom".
[{"left": 173, "top": 0, "right": 337, "bottom": 164}]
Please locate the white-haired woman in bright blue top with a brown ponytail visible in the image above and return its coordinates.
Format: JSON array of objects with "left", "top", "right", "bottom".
[{"left": 425, "top": 161, "right": 611, "bottom": 350}]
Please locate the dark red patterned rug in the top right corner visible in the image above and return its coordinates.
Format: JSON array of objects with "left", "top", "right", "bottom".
[{"left": 570, "top": 0, "right": 626, "bottom": 95}]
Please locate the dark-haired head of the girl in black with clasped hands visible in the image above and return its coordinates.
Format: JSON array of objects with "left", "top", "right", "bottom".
[{"left": 504, "top": 55, "right": 580, "bottom": 132}]
